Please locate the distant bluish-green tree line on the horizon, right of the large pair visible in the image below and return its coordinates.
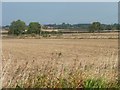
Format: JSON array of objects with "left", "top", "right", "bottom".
[{"left": 46, "top": 22, "right": 120, "bottom": 32}]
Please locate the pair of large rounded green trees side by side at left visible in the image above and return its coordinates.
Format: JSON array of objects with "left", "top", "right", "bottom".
[{"left": 8, "top": 20, "right": 41, "bottom": 35}]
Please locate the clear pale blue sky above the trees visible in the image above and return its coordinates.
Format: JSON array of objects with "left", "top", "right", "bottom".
[{"left": 2, "top": 2, "right": 118, "bottom": 25}]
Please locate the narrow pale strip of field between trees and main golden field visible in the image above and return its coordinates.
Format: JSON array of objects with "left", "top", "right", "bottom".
[{"left": 2, "top": 32, "right": 118, "bottom": 39}]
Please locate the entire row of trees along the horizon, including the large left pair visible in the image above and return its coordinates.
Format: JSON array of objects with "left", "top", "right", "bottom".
[{"left": 3, "top": 20, "right": 120, "bottom": 35}]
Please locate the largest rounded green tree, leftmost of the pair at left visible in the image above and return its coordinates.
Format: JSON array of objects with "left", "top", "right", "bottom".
[{"left": 9, "top": 20, "right": 26, "bottom": 35}]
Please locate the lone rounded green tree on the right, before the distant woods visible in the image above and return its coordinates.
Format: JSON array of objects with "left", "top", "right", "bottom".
[{"left": 89, "top": 22, "right": 102, "bottom": 32}]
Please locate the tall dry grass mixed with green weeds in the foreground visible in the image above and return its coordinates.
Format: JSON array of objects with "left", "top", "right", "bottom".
[{"left": 2, "top": 51, "right": 118, "bottom": 88}]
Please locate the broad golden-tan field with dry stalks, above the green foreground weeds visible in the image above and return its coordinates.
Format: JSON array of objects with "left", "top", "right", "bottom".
[{"left": 2, "top": 39, "right": 118, "bottom": 87}]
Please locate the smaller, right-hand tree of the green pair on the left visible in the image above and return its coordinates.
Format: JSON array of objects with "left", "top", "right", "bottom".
[{"left": 28, "top": 22, "right": 41, "bottom": 34}]
